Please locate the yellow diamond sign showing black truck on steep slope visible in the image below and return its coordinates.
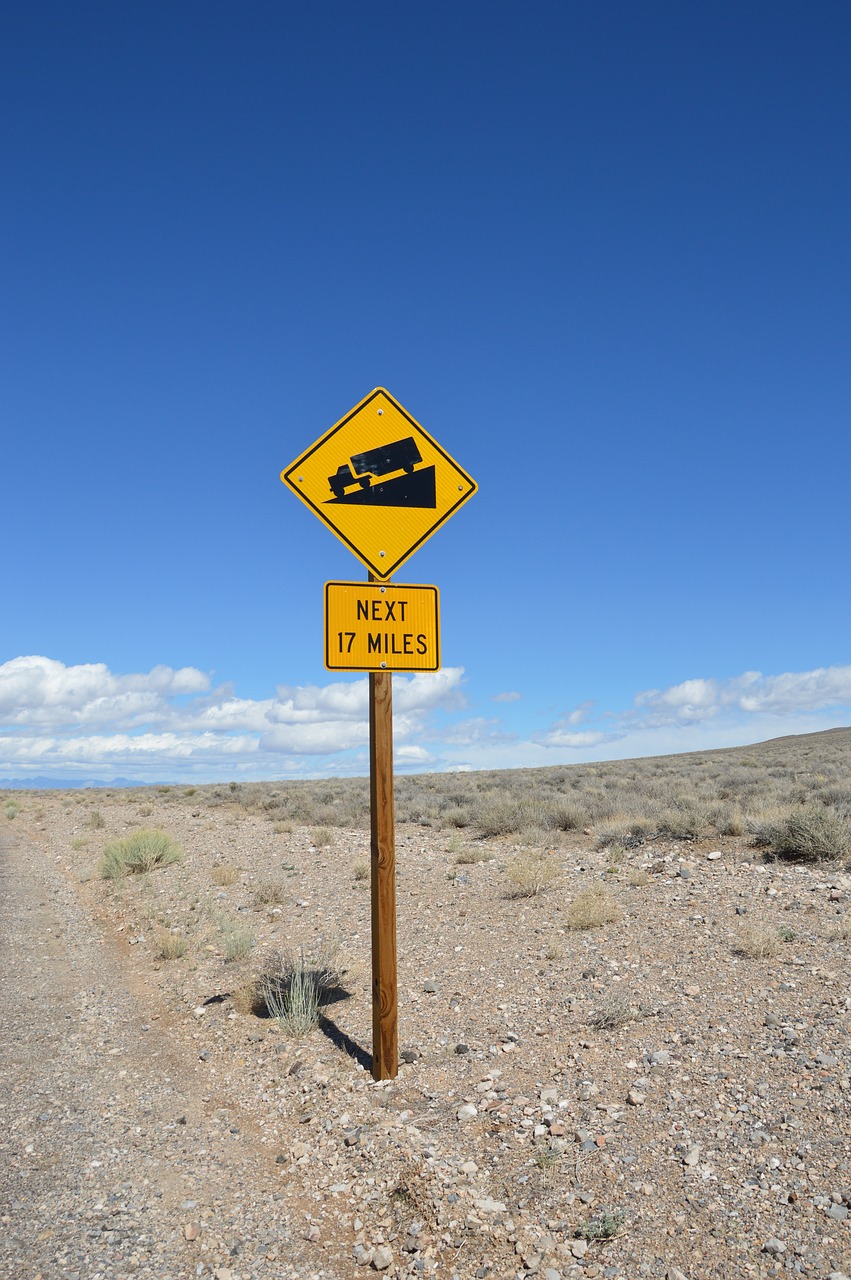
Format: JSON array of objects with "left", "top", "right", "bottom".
[{"left": 280, "top": 387, "right": 477, "bottom": 579}]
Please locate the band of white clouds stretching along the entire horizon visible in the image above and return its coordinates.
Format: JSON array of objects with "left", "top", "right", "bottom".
[{"left": 0, "top": 655, "right": 851, "bottom": 783}]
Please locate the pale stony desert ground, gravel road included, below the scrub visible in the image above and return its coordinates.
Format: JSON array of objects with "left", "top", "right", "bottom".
[{"left": 0, "top": 788, "right": 851, "bottom": 1280}]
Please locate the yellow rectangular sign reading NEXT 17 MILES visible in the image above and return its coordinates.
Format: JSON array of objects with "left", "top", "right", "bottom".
[{"left": 325, "top": 582, "right": 440, "bottom": 671}]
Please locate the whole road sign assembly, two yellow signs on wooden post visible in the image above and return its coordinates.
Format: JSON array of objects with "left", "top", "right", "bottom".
[{"left": 280, "top": 387, "right": 477, "bottom": 1080}]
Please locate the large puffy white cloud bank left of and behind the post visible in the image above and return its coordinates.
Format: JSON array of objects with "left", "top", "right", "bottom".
[{"left": 0, "top": 657, "right": 465, "bottom": 781}]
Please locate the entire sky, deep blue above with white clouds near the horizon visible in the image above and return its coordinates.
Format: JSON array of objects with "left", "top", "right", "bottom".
[{"left": 0, "top": 0, "right": 851, "bottom": 781}]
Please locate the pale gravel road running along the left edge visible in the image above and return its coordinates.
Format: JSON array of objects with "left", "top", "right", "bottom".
[{"left": 0, "top": 833, "right": 339, "bottom": 1280}]
